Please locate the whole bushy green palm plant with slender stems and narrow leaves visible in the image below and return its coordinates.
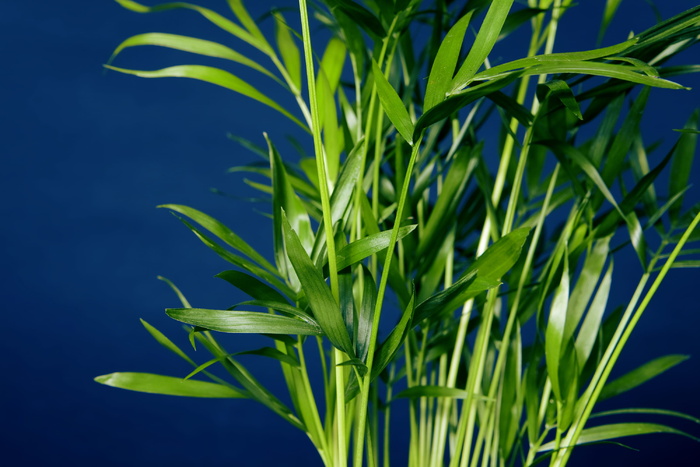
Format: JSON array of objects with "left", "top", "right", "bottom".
[{"left": 97, "top": 0, "right": 700, "bottom": 466}]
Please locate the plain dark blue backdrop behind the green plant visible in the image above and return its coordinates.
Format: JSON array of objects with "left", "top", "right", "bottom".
[{"left": 0, "top": 0, "right": 700, "bottom": 466}]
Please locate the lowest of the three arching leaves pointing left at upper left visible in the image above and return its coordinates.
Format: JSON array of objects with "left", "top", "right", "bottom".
[{"left": 105, "top": 65, "right": 308, "bottom": 131}]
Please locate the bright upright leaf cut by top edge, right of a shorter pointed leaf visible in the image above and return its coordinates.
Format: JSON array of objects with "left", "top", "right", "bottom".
[{"left": 451, "top": 0, "right": 513, "bottom": 91}]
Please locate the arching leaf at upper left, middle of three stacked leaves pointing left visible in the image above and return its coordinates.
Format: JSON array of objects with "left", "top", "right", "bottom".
[{"left": 107, "top": 32, "right": 278, "bottom": 80}]
